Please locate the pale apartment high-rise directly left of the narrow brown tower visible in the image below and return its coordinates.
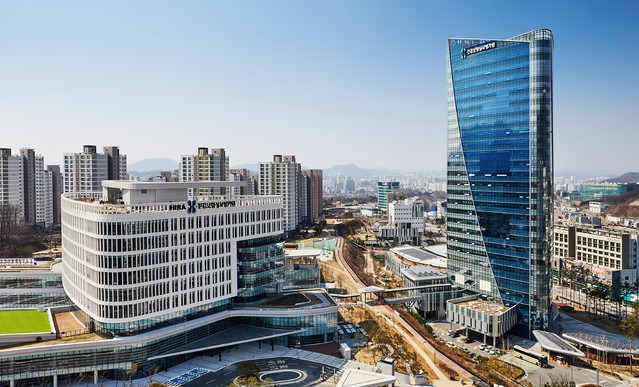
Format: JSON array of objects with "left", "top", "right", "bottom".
[{"left": 259, "top": 155, "right": 302, "bottom": 235}]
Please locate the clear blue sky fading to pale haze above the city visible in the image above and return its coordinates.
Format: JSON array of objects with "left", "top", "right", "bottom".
[{"left": 0, "top": 0, "right": 639, "bottom": 174}]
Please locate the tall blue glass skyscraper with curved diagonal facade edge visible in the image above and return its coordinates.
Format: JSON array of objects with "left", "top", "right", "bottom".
[{"left": 447, "top": 30, "right": 553, "bottom": 334}]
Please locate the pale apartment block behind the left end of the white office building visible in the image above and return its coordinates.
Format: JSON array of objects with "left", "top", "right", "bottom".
[{"left": 63, "top": 145, "right": 128, "bottom": 193}]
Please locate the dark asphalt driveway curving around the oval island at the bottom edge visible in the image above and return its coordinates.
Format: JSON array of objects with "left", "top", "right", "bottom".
[{"left": 184, "top": 358, "right": 337, "bottom": 387}]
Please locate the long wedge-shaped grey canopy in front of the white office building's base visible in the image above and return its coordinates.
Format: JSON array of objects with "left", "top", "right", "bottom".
[{"left": 149, "top": 324, "right": 305, "bottom": 360}]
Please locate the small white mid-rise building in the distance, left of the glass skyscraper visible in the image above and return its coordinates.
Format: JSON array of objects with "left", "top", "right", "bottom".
[{"left": 379, "top": 197, "right": 424, "bottom": 245}]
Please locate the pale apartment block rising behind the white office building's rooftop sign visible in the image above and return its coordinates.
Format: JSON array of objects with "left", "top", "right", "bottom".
[{"left": 179, "top": 147, "right": 229, "bottom": 196}]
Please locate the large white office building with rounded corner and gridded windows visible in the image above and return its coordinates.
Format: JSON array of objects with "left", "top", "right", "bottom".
[{"left": 62, "top": 181, "right": 282, "bottom": 331}]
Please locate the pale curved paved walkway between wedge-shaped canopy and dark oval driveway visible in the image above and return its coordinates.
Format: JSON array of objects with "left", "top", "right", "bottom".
[{"left": 73, "top": 343, "right": 377, "bottom": 387}]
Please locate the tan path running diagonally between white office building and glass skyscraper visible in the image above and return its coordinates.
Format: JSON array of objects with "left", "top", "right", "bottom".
[{"left": 335, "top": 238, "right": 472, "bottom": 386}]
